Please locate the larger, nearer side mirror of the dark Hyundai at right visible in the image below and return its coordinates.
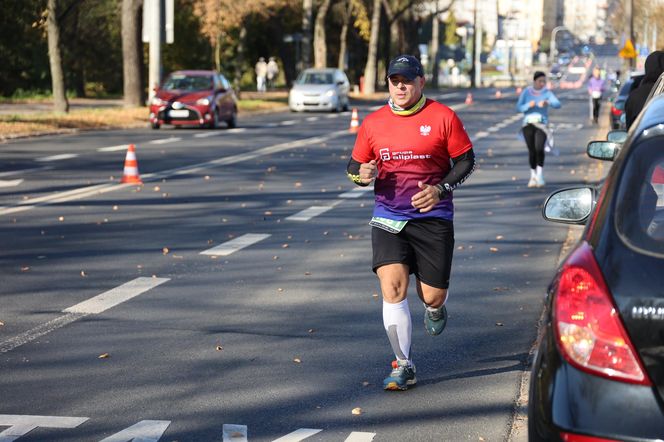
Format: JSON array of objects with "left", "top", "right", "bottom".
[{"left": 542, "top": 187, "right": 595, "bottom": 225}]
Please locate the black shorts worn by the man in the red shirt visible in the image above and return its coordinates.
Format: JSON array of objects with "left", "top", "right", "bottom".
[{"left": 371, "top": 218, "right": 454, "bottom": 289}]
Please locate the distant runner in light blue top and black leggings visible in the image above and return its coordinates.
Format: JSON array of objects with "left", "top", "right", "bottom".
[{"left": 516, "top": 71, "right": 560, "bottom": 187}]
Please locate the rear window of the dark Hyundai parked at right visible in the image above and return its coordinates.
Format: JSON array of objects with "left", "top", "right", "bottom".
[{"left": 616, "top": 135, "right": 664, "bottom": 255}]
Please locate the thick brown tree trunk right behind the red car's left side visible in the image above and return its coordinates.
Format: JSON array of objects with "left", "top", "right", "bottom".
[{"left": 122, "top": 0, "right": 143, "bottom": 107}]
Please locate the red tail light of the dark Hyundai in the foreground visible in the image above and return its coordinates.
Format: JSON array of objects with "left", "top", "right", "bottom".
[{"left": 553, "top": 242, "right": 651, "bottom": 385}]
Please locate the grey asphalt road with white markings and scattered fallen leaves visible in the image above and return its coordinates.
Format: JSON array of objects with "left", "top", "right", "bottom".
[{"left": 0, "top": 84, "right": 608, "bottom": 442}]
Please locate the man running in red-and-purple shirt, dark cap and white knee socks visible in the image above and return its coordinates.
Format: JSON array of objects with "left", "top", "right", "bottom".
[{"left": 347, "top": 55, "right": 475, "bottom": 390}]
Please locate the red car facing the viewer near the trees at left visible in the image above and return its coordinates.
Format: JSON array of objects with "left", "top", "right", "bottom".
[{"left": 150, "top": 71, "right": 237, "bottom": 129}]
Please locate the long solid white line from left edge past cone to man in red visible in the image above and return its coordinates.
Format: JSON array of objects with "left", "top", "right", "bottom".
[{"left": 0, "top": 130, "right": 348, "bottom": 216}]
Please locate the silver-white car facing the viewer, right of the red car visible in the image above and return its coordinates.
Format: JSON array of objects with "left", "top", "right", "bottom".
[{"left": 288, "top": 68, "right": 350, "bottom": 112}]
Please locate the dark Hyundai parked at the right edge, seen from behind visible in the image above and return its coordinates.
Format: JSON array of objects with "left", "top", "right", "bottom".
[{"left": 528, "top": 95, "right": 664, "bottom": 442}]
